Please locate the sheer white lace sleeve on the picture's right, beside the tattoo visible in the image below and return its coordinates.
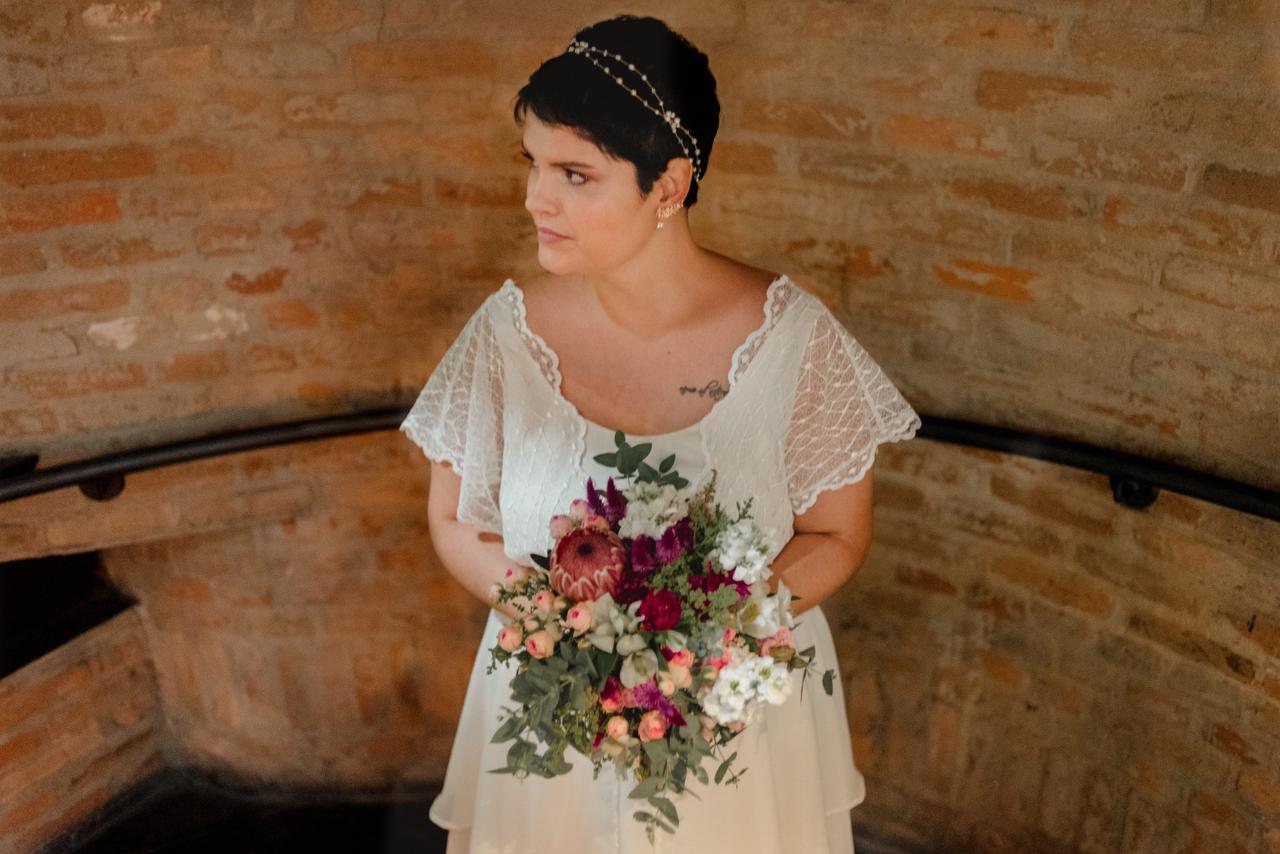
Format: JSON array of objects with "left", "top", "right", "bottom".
[{"left": 783, "top": 311, "right": 920, "bottom": 516}]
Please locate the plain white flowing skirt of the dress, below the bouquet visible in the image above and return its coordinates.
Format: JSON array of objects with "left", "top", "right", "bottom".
[{"left": 429, "top": 607, "right": 867, "bottom": 854}]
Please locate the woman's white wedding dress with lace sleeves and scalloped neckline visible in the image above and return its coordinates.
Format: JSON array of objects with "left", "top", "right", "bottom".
[{"left": 401, "top": 275, "right": 920, "bottom": 854}]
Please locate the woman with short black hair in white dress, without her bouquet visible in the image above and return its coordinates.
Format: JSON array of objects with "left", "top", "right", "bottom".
[{"left": 401, "top": 17, "right": 920, "bottom": 854}]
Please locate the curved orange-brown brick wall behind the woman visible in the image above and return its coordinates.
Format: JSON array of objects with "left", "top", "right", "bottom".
[{"left": 0, "top": 0, "right": 1280, "bottom": 851}]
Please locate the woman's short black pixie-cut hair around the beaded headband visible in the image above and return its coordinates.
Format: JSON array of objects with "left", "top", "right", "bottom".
[{"left": 512, "top": 15, "right": 719, "bottom": 207}]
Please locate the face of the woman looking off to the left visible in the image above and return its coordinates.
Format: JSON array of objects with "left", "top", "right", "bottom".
[{"left": 522, "top": 113, "right": 660, "bottom": 274}]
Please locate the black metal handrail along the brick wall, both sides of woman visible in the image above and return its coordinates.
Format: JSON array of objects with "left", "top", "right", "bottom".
[{"left": 0, "top": 407, "right": 1280, "bottom": 521}]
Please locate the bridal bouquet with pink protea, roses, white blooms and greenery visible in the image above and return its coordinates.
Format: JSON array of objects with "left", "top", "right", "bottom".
[{"left": 488, "top": 431, "right": 835, "bottom": 842}]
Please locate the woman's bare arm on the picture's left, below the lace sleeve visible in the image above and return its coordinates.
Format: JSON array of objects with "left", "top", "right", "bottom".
[{"left": 426, "top": 460, "right": 518, "bottom": 620}]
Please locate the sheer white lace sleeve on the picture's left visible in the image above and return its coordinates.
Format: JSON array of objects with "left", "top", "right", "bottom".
[{"left": 399, "top": 302, "right": 503, "bottom": 534}]
